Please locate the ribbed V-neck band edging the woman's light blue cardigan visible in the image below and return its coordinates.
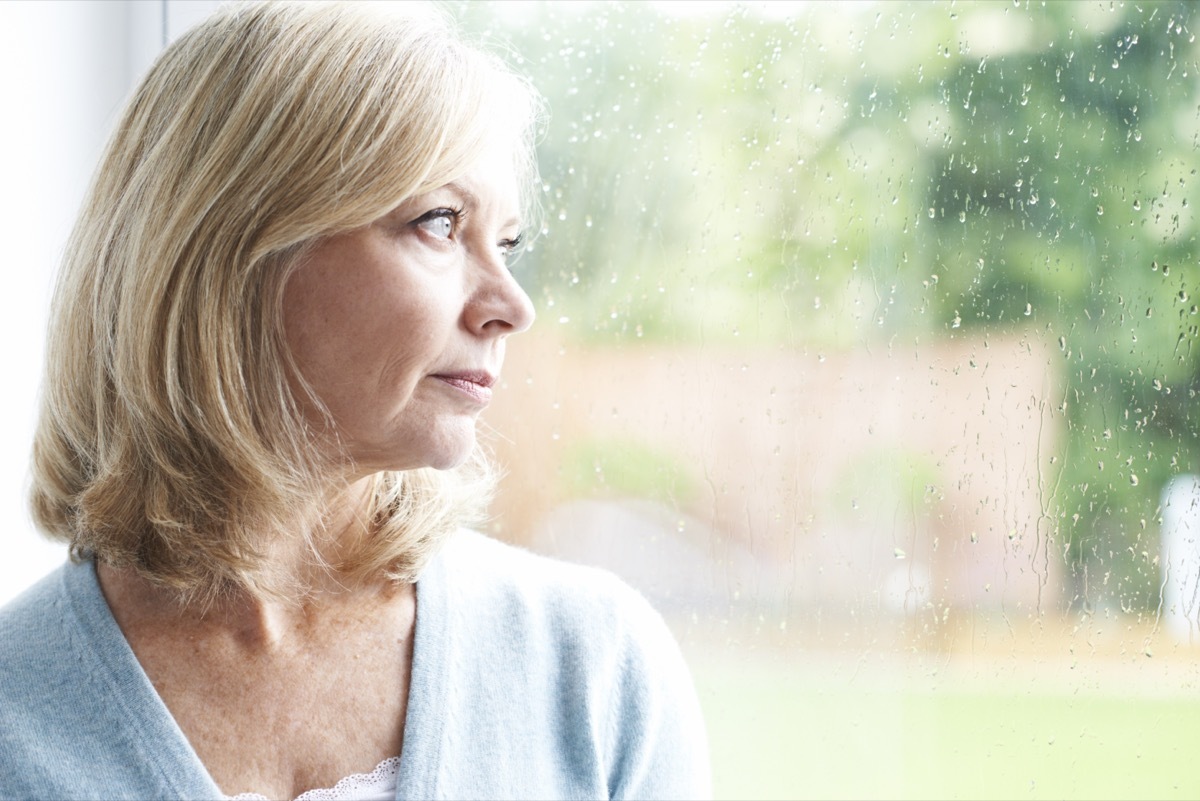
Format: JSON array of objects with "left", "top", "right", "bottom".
[{"left": 62, "top": 542, "right": 450, "bottom": 800}]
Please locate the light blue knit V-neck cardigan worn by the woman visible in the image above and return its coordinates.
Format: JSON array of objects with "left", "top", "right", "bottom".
[{"left": 0, "top": 532, "right": 709, "bottom": 799}]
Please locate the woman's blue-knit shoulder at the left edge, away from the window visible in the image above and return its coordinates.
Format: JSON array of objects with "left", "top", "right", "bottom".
[{"left": 0, "top": 561, "right": 216, "bottom": 799}]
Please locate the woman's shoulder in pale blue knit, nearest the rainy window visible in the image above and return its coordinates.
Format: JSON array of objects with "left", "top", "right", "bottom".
[{"left": 416, "top": 532, "right": 710, "bottom": 797}]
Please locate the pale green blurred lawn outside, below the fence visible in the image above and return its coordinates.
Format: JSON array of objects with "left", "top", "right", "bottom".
[{"left": 690, "top": 654, "right": 1200, "bottom": 799}]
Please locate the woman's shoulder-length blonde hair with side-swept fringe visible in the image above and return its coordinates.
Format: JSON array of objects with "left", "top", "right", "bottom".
[{"left": 31, "top": 2, "right": 538, "bottom": 600}]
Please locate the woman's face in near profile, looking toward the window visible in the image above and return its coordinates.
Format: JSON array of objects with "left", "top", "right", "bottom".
[{"left": 283, "top": 143, "right": 534, "bottom": 476}]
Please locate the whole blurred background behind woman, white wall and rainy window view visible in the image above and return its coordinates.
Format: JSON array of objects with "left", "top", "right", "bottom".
[{"left": 7, "top": 0, "right": 1200, "bottom": 799}]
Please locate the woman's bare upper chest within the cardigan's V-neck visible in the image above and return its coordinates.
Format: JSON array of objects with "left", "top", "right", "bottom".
[{"left": 130, "top": 618, "right": 412, "bottom": 799}]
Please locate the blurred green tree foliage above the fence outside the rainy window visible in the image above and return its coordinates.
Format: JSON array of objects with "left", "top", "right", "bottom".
[{"left": 455, "top": 2, "right": 1200, "bottom": 606}]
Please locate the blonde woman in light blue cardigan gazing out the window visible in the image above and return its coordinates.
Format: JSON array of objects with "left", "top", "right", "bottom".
[{"left": 0, "top": 4, "right": 708, "bottom": 799}]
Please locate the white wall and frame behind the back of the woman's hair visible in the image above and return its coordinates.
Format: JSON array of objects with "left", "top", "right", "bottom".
[{"left": 0, "top": 0, "right": 216, "bottom": 604}]
